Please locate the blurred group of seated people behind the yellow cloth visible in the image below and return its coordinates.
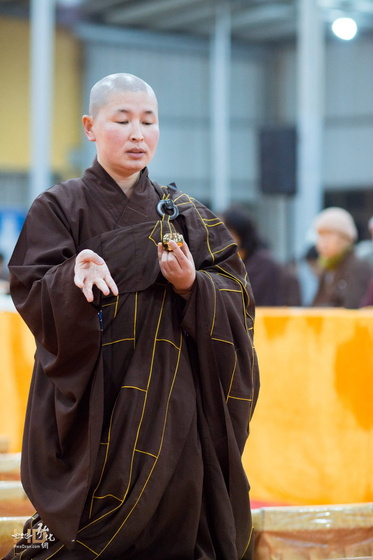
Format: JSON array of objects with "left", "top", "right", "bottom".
[{"left": 222, "top": 206, "right": 373, "bottom": 309}]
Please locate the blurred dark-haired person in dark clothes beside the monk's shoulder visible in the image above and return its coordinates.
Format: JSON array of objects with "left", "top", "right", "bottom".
[{"left": 222, "top": 205, "right": 301, "bottom": 307}]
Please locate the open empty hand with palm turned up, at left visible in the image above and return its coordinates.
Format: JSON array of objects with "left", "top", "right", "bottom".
[{"left": 74, "top": 249, "right": 118, "bottom": 302}]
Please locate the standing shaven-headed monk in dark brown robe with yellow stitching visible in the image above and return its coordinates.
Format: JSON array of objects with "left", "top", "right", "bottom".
[{"left": 6, "top": 74, "right": 259, "bottom": 560}]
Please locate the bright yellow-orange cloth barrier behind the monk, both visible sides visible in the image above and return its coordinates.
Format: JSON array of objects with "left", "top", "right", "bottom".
[{"left": 0, "top": 308, "right": 373, "bottom": 505}]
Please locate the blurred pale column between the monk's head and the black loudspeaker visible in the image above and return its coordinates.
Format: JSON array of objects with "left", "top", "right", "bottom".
[{"left": 210, "top": 0, "right": 231, "bottom": 212}]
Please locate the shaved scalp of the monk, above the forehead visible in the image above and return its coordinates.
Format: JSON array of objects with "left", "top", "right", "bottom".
[{"left": 89, "top": 73, "right": 156, "bottom": 117}]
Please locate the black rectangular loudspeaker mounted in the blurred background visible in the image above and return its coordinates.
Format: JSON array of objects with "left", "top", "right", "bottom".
[{"left": 259, "top": 126, "right": 297, "bottom": 195}]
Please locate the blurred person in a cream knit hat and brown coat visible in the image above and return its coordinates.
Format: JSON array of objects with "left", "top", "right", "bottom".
[{"left": 312, "top": 207, "right": 372, "bottom": 309}]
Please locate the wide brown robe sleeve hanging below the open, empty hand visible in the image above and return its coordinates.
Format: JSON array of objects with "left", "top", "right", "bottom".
[{"left": 9, "top": 192, "right": 103, "bottom": 546}]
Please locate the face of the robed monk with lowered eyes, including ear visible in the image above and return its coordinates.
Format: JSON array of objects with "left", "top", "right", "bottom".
[{"left": 83, "top": 91, "right": 159, "bottom": 179}]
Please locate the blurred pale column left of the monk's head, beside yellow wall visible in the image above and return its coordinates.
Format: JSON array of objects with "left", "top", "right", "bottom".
[{"left": 29, "top": 0, "right": 56, "bottom": 203}]
